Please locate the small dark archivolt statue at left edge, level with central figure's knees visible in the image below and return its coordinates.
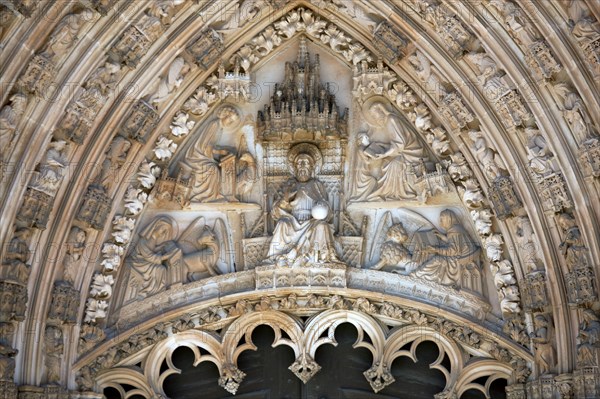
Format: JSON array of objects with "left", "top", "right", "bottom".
[{"left": 1, "top": 229, "right": 33, "bottom": 284}]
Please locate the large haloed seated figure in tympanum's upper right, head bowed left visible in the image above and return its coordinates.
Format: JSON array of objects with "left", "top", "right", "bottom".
[{"left": 363, "top": 97, "right": 424, "bottom": 200}]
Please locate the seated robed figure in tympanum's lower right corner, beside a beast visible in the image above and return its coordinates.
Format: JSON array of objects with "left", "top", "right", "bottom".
[{"left": 415, "top": 209, "right": 480, "bottom": 287}]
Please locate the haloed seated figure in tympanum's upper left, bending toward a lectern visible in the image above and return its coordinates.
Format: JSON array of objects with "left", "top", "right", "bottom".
[{"left": 181, "top": 106, "right": 240, "bottom": 202}]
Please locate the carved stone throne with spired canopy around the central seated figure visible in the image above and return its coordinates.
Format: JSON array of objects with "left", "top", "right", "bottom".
[{"left": 243, "top": 38, "right": 364, "bottom": 269}]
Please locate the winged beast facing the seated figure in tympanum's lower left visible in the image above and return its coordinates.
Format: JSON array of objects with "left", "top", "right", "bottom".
[{"left": 177, "top": 217, "right": 235, "bottom": 282}]
